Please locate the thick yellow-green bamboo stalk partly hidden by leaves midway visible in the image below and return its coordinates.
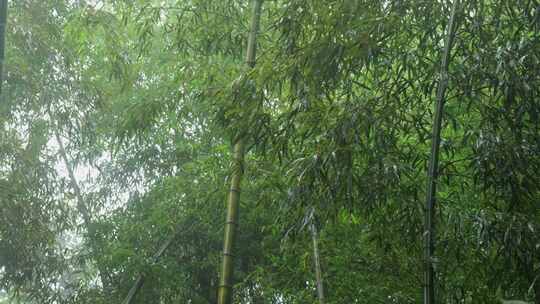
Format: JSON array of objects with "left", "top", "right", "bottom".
[{"left": 218, "top": 0, "right": 262, "bottom": 304}]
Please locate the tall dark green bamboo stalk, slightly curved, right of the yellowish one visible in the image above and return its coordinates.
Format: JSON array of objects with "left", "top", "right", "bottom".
[{"left": 424, "top": 0, "right": 459, "bottom": 304}]
